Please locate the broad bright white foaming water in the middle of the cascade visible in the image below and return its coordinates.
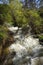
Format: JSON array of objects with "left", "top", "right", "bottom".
[{"left": 9, "top": 36, "right": 39, "bottom": 55}]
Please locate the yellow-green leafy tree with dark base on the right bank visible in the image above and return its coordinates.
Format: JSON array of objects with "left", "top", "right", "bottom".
[{"left": 25, "top": 10, "right": 43, "bottom": 34}]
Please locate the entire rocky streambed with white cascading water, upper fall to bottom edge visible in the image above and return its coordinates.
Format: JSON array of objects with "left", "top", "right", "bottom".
[{"left": 3, "top": 27, "right": 43, "bottom": 65}]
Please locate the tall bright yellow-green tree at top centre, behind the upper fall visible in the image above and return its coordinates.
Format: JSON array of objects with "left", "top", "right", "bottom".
[{"left": 9, "top": 0, "right": 27, "bottom": 26}]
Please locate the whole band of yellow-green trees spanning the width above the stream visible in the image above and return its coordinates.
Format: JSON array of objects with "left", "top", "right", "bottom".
[{"left": 0, "top": 0, "right": 43, "bottom": 37}]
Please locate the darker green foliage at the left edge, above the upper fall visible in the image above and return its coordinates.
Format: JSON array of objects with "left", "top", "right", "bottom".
[{"left": 0, "top": 4, "right": 12, "bottom": 23}]
